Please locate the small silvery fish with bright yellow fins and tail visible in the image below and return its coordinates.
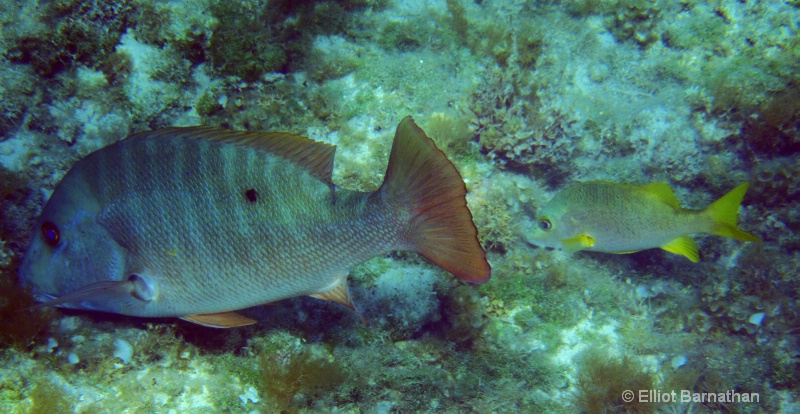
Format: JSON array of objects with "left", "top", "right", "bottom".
[{"left": 528, "top": 182, "right": 761, "bottom": 262}]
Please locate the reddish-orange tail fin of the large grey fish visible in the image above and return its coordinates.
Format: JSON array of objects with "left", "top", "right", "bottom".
[{"left": 378, "top": 116, "right": 491, "bottom": 283}]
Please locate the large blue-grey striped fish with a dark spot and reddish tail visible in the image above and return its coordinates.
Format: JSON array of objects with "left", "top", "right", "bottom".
[{"left": 20, "top": 117, "right": 491, "bottom": 327}]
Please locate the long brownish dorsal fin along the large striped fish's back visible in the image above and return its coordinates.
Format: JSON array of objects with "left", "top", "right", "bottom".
[{"left": 134, "top": 126, "right": 336, "bottom": 186}]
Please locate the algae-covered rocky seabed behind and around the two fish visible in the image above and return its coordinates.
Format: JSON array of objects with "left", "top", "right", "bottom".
[{"left": 0, "top": 0, "right": 800, "bottom": 413}]
